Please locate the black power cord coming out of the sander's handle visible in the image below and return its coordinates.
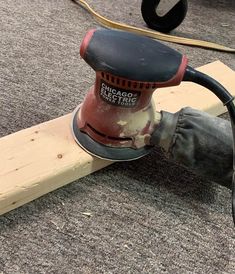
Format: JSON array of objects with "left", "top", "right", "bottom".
[{"left": 183, "top": 66, "right": 235, "bottom": 226}]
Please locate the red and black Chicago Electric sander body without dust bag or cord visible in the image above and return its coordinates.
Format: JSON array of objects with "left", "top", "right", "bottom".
[{"left": 72, "top": 29, "right": 187, "bottom": 161}]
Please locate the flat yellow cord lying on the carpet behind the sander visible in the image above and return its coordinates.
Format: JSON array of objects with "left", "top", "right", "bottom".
[{"left": 71, "top": 0, "right": 235, "bottom": 53}]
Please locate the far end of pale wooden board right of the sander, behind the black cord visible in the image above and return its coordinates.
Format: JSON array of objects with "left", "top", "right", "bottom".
[{"left": 153, "top": 61, "right": 235, "bottom": 116}]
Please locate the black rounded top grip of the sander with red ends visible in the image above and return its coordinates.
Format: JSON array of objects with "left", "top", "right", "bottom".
[{"left": 81, "top": 29, "right": 187, "bottom": 83}]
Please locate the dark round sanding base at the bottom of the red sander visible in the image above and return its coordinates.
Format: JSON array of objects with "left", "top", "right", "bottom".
[{"left": 72, "top": 105, "right": 153, "bottom": 162}]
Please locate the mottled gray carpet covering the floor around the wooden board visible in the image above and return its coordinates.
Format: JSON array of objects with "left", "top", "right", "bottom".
[{"left": 0, "top": 0, "right": 235, "bottom": 274}]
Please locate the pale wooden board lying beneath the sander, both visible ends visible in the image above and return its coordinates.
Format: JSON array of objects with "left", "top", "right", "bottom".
[{"left": 0, "top": 61, "right": 235, "bottom": 214}]
